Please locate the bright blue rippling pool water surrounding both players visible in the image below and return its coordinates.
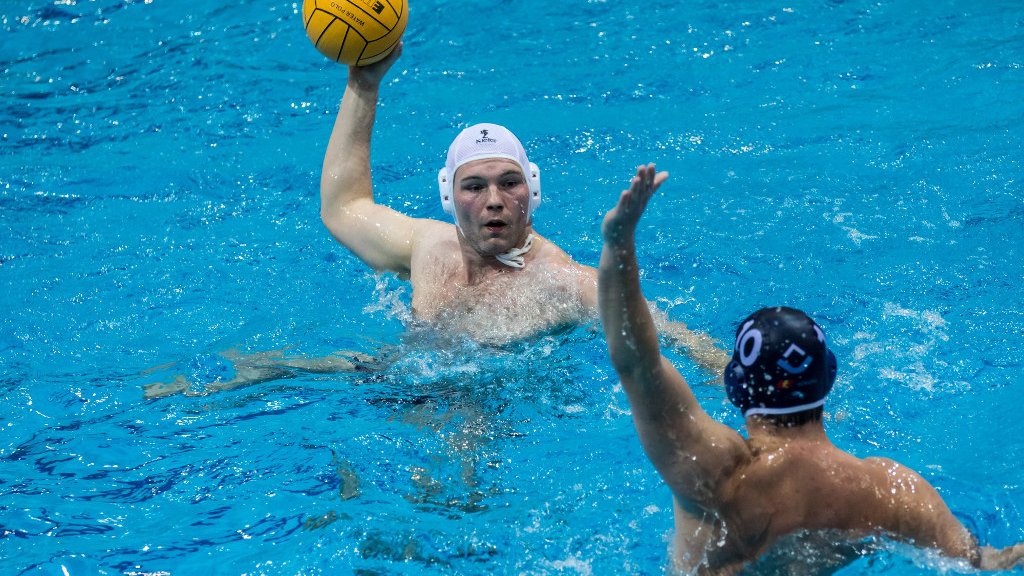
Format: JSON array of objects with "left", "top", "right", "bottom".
[{"left": 0, "top": 0, "right": 1024, "bottom": 575}]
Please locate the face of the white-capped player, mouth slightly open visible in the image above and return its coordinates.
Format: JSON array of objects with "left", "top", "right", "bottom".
[{"left": 453, "top": 158, "right": 529, "bottom": 256}]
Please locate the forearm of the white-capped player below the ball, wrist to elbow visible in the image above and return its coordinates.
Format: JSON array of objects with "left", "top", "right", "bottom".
[{"left": 321, "top": 75, "right": 379, "bottom": 222}]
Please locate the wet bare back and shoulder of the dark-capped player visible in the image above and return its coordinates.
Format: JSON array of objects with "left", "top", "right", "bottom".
[{"left": 675, "top": 425, "right": 974, "bottom": 574}]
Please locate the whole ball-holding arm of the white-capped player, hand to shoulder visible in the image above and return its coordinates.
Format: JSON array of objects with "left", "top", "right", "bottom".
[{"left": 321, "top": 44, "right": 422, "bottom": 273}]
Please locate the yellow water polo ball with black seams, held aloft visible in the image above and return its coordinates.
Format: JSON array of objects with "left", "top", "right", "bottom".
[{"left": 302, "top": 0, "right": 409, "bottom": 66}]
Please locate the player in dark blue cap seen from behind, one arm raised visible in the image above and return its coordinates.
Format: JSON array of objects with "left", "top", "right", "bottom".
[{"left": 598, "top": 159, "right": 1024, "bottom": 574}]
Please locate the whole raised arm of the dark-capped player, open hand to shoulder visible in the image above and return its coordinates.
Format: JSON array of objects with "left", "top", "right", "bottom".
[{"left": 598, "top": 164, "right": 749, "bottom": 507}]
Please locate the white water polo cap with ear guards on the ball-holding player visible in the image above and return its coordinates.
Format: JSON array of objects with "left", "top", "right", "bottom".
[{"left": 437, "top": 124, "right": 541, "bottom": 217}]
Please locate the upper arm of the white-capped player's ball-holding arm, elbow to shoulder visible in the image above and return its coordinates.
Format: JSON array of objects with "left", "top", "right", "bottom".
[{"left": 321, "top": 199, "right": 432, "bottom": 274}]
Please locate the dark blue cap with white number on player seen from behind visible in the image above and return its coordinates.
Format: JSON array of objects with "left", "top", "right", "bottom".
[{"left": 724, "top": 306, "right": 836, "bottom": 416}]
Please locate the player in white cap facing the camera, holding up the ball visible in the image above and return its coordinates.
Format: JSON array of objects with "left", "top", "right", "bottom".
[{"left": 321, "top": 44, "right": 728, "bottom": 362}]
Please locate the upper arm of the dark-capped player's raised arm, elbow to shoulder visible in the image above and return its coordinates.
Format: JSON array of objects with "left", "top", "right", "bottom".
[{"left": 620, "top": 357, "right": 750, "bottom": 508}]
